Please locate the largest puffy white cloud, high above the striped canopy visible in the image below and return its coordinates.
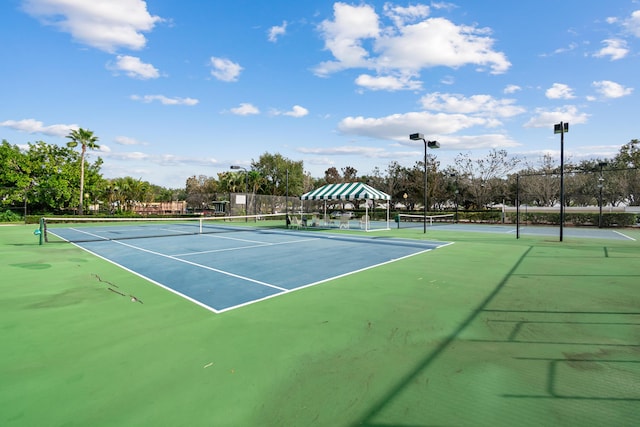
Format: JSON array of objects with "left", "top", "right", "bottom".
[{"left": 314, "top": 2, "right": 511, "bottom": 82}]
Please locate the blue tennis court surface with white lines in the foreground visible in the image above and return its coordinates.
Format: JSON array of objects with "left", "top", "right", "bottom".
[{"left": 50, "top": 228, "right": 450, "bottom": 313}]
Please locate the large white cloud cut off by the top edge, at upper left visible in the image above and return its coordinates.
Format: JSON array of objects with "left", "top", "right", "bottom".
[{"left": 24, "top": 0, "right": 162, "bottom": 53}]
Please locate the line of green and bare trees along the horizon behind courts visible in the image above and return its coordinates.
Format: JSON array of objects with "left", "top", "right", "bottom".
[{"left": 0, "top": 129, "right": 640, "bottom": 219}]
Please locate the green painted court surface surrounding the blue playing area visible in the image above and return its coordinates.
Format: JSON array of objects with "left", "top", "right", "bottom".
[{"left": 0, "top": 226, "right": 640, "bottom": 427}]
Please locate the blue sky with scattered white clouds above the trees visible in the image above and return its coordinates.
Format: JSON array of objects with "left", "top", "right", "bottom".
[{"left": 0, "top": 0, "right": 640, "bottom": 188}]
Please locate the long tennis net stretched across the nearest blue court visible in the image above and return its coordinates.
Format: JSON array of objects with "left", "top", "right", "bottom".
[{"left": 41, "top": 214, "right": 286, "bottom": 243}]
